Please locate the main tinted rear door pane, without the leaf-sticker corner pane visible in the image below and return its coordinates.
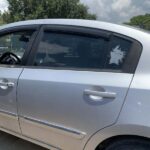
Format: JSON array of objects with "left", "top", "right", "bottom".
[{"left": 34, "top": 32, "right": 108, "bottom": 69}]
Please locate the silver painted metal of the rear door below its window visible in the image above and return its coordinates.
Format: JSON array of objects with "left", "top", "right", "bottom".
[{"left": 18, "top": 68, "right": 133, "bottom": 150}]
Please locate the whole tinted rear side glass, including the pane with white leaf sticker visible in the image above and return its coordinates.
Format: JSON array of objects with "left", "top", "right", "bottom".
[{"left": 34, "top": 32, "right": 131, "bottom": 70}]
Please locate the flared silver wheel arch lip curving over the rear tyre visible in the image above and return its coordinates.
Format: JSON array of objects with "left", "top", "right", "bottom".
[{"left": 83, "top": 124, "right": 150, "bottom": 150}]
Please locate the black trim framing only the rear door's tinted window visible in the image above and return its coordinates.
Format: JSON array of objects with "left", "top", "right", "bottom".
[{"left": 27, "top": 25, "right": 143, "bottom": 74}]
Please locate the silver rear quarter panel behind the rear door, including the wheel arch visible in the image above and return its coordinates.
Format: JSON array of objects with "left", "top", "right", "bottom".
[{"left": 84, "top": 34, "right": 150, "bottom": 150}]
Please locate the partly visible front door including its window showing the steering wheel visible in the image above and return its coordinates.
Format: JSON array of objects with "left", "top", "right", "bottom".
[{"left": 0, "top": 27, "right": 38, "bottom": 133}]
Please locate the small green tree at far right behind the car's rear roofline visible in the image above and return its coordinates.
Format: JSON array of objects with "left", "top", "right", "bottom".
[{"left": 125, "top": 14, "right": 150, "bottom": 30}]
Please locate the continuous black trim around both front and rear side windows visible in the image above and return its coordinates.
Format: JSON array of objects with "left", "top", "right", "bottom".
[{"left": 0, "top": 24, "right": 143, "bottom": 74}]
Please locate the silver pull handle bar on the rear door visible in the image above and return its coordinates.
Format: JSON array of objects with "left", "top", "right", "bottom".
[{"left": 84, "top": 90, "right": 116, "bottom": 99}]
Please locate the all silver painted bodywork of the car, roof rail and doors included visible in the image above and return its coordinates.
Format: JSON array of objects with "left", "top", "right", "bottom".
[{"left": 0, "top": 19, "right": 150, "bottom": 150}]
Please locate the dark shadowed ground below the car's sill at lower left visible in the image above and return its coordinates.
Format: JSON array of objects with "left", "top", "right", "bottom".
[{"left": 0, "top": 131, "right": 47, "bottom": 150}]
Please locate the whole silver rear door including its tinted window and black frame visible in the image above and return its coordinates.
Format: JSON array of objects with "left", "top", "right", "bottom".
[{"left": 18, "top": 26, "right": 140, "bottom": 150}]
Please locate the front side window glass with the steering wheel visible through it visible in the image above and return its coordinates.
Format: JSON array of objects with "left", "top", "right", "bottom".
[{"left": 0, "top": 31, "right": 34, "bottom": 64}]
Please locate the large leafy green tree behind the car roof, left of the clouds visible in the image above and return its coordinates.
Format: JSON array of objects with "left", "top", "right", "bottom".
[{"left": 3, "top": 0, "right": 96, "bottom": 23}]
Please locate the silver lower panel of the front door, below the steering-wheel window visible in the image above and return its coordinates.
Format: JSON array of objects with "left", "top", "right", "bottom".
[{"left": 0, "top": 67, "right": 22, "bottom": 132}]
